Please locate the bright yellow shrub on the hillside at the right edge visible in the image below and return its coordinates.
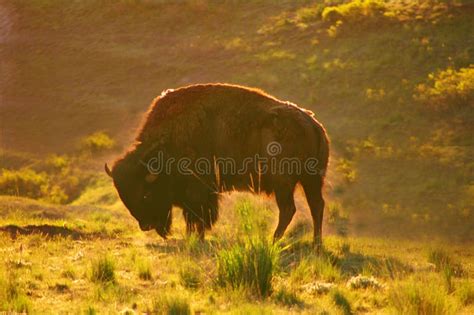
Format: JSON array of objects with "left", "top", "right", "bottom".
[{"left": 414, "top": 66, "right": 474, "bottom": 109}]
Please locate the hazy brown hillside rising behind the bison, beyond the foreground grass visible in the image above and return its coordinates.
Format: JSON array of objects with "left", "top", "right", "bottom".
[{"left": 0, "top": 0, "right": 474, "bottom": 241}]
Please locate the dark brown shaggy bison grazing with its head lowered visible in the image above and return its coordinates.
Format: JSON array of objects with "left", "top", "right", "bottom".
[{"left": 105, "top": 84, "right": 329, "bottom": 247}]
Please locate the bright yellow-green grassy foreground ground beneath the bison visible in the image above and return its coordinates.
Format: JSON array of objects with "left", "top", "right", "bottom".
[{"left": 0, "top": 194, "right": 474, "bottom": 314}]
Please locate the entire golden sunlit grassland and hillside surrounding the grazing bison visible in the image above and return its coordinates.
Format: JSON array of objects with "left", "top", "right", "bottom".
[{"left": 0, "top": 0, "right": 474, "bottom": 314}]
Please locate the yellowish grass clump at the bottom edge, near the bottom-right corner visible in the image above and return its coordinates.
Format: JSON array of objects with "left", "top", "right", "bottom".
[{"left": 389, "top": 278, "right": 457, "bottom": 315}]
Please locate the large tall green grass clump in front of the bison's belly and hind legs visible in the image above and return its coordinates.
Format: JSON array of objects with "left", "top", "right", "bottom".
[{"left": 217, "top": 238, "right": 281, "bottom": 297}]
